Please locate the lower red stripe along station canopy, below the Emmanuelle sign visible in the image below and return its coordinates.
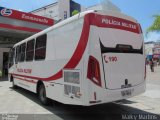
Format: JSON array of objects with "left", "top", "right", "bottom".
[{"left": 0, "top": 23, "right": 42, "bottom": 33}]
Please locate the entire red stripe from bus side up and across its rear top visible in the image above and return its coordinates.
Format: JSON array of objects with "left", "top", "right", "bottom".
[{"left": 10, "top": 13, "right": 140, "bottom": 81}]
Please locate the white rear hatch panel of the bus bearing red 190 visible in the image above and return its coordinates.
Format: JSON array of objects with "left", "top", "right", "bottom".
[{"left": 98, "top": 28, "right": 145, "bottom": 89}]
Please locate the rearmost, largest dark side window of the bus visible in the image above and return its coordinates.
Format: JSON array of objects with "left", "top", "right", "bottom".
[{"left": 35, "top": 34, "right": 47, "bottom": 60}]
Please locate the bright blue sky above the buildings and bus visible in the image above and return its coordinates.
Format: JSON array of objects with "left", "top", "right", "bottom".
[{"left": 0, "top": 0, "right": 160, "bottom": 41}]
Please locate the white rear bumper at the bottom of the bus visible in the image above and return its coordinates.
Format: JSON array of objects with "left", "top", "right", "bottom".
[{"left": 86, "top": 82, "right": 146, "bottom": 106}]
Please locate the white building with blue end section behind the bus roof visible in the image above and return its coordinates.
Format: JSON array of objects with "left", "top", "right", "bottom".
[{"left": 30, "top": 0, "right": 86, "bottom": 22}]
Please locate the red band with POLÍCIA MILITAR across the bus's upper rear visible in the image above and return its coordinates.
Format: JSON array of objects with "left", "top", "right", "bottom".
[{"left": 90, "top": 13, "right": 142, "bottom": 34}]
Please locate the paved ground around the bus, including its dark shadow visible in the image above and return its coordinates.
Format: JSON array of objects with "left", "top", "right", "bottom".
[{"left": 0, "top": 67, "right": 160, "bottom": 120}]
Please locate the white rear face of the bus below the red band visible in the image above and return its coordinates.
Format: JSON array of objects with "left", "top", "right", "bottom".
[{"left": 85, "top": 17, "right": 146, "bottom": 105}]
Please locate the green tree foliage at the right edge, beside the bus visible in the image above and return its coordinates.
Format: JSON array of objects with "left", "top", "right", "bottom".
[{"left": 147, "top": 15, "right": 160, "bottom": 33}]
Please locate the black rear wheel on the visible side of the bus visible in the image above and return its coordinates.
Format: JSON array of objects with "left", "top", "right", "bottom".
[{"left": 38, "top": 84, "right": 49, "bottom": 105}]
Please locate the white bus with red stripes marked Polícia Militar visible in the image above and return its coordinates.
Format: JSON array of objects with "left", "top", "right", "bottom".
[{"left": 9, "top": 10, "right": 145, "bottom": 106}]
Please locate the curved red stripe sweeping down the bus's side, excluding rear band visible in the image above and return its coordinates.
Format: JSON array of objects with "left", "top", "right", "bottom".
[{"left": 10, "top": 14, "right": 90, "bottom": 81}]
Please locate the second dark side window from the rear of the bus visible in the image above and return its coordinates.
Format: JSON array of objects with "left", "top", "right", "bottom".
[{"left": 26, "top": 39, "right": 35, "bottom": 61}]
